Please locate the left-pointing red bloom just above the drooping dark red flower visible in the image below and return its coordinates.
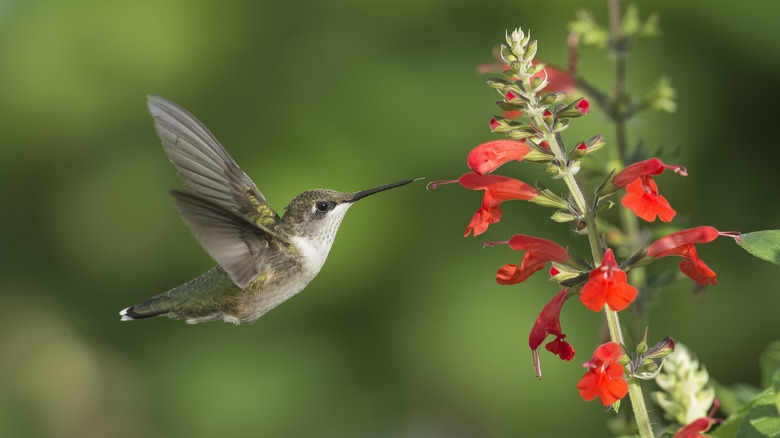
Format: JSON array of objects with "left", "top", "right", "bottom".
[{"left": 485, "top": 234, "right": 569, "bottom": 284}]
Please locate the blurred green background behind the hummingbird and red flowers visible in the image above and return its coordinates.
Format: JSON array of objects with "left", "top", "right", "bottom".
[{"left": 0, "top": 0, "right": 780, "bottom": 437}]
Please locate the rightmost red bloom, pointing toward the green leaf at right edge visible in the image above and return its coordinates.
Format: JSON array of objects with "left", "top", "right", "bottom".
[{"left": 647, "top": 226, "right": 723, "bottom": 286}]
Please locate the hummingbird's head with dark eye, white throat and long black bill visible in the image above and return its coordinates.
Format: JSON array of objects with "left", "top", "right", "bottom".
[{"left": 282, "top": 180, "right": 412, "bottom": 242}]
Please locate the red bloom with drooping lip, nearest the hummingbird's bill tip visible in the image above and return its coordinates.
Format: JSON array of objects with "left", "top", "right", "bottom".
[{"left": 428, "top": 173, "right": 539, "bottom": 237}]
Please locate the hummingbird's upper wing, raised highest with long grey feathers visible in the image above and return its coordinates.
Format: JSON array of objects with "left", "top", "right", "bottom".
[{"left": 148, "top": 95, "right": 279, "bottom": 228}]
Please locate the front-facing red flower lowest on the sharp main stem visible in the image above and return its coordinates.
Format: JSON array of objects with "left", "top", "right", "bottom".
[{"left": 577, "top": 342, "right": 628, "bottom": 406}]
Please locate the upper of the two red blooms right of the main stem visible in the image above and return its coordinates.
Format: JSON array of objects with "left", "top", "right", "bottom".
[{"left": 612, "top": 158, "right": 688, "bottom": 222}]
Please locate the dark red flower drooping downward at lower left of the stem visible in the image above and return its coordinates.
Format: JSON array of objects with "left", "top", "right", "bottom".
[{"left": 528, "top": 289, "right": 574, "bottom": 379}]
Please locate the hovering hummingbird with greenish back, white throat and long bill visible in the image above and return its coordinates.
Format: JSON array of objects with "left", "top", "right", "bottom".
[{"left": 119, "top": 95, "right": 414, "bottom": 324}]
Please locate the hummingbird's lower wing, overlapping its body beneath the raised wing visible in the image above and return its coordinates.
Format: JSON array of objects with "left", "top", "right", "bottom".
[{"left": 171, "top": 190, "right": 288, "bottom": 289}]
